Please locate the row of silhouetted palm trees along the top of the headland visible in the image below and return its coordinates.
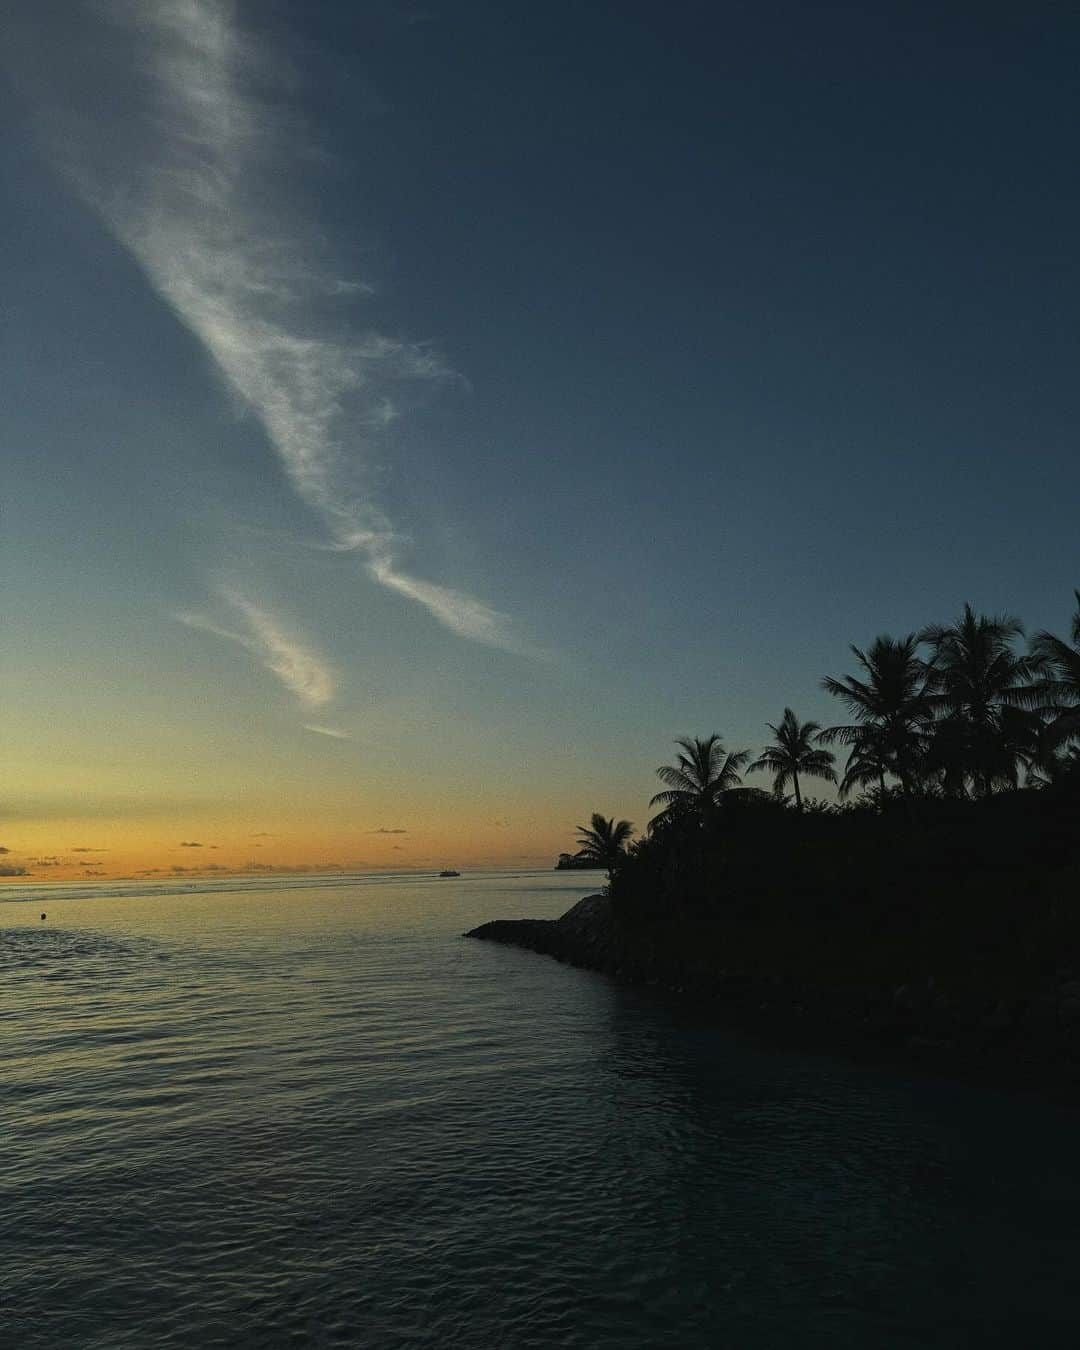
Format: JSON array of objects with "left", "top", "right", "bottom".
[{"left": 556, "top": 590, "right": 1080, "bottom": 888}]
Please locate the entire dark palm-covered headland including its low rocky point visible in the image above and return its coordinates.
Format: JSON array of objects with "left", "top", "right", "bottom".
[{"left": 488, "top": 591, "right": 1080, "bottom": 1091}]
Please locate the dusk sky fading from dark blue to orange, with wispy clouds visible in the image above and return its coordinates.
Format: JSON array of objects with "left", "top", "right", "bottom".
[{"left": 0, "top": 0, "right": 1080, "bottom": 882}]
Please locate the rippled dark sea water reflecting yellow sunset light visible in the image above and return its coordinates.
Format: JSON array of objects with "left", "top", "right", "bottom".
[{"left": 0, "top": 873, "right": 1080, "bottom": 1350}]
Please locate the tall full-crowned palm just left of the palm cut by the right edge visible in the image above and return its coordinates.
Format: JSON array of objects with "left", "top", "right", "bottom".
[{"left": 919, "top": 605, "right": 1038, "bottom": 797}]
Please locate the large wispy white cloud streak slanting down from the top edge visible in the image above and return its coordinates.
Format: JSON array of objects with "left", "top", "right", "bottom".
[{"left": 46, "top": 0, "right": 528, "bottom": 652}]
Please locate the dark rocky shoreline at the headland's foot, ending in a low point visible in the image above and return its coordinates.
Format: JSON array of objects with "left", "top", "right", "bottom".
[{"left": 464, "top": 895, "right": 1080, "bottom": 1103}]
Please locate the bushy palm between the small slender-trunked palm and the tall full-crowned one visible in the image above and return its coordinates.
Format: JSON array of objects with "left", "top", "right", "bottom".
[{"left": 817, "top": 633, "right": 930, "bottom": 801}]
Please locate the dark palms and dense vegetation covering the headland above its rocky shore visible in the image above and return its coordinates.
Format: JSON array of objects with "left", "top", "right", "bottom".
[{"left": 561, "top": 591, "right": 1080, "bottom": 977}]
